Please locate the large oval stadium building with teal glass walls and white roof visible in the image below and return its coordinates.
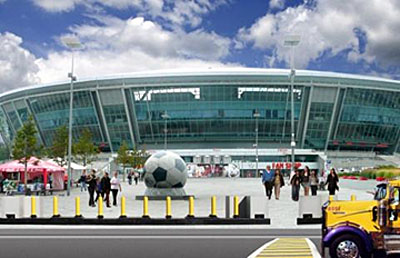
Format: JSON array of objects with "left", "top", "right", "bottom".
[{"left": 0, "top": 68, "right": 400, "bottom": 173}]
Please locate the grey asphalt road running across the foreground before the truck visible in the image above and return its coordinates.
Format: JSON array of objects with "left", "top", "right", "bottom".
[{"left": 0, "top": 226, "right": 321, "bottom": 258}]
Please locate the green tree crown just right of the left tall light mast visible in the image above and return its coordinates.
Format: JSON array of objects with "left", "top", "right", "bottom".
[{"left": 72, "top": 128, "right": 98, "bottom": 166}]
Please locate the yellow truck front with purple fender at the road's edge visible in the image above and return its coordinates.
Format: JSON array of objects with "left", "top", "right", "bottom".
[{"left": 321, "top": 180, "right": 400, "bottom": 258}]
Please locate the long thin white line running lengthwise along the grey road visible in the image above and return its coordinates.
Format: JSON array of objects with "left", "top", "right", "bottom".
[{"left": 0, "top": 235, "right": 320, "bottom": 239}]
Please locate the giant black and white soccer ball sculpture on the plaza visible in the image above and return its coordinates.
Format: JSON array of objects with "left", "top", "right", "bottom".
[{"left": 144, "top": 151, "right": 187, "bottom": 188}]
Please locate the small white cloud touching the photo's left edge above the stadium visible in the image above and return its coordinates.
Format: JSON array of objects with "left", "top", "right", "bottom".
[{"left": 0, "top": 32, "right": 39, "bottom": 91}]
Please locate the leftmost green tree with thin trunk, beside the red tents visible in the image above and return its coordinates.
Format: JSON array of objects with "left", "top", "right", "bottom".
[{"left": 12, "top": 116, "right": 42, "bottom": 193}]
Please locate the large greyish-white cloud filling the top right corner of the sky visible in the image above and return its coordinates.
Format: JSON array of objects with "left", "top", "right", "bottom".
[{"left": 237, "top": 0, "right": 400, "bottom": 70}]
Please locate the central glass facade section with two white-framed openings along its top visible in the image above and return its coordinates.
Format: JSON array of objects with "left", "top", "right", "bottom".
[{"left": 133, "top": 85, "right": 302, "bottom": 144}]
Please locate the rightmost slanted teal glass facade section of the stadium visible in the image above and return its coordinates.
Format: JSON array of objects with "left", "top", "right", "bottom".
[{"left": 336, "top": 88, "right": 400, "bottom": 151}]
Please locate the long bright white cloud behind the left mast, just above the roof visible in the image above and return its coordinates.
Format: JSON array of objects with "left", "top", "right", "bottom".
[{"left": 32, "top": 16, "right": 238, "bottom": 83}]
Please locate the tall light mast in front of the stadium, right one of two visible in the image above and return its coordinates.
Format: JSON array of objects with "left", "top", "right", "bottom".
[{"left": 284, "top": 35, "right": 300, "bottom": 174}]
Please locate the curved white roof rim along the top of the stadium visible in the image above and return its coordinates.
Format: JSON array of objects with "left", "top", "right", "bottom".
[{"left": 0, "top": 68, "right": 400, "bottom": 102}]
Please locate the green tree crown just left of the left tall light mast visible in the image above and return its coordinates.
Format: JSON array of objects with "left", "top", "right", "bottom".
[{"left": 49, "top": 125, "right": 68, "bottom": 167}]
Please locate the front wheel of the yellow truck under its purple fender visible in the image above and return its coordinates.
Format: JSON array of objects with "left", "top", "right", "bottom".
[{"left": 329, "top": 234, "right": 371, "bottom": 258}]
